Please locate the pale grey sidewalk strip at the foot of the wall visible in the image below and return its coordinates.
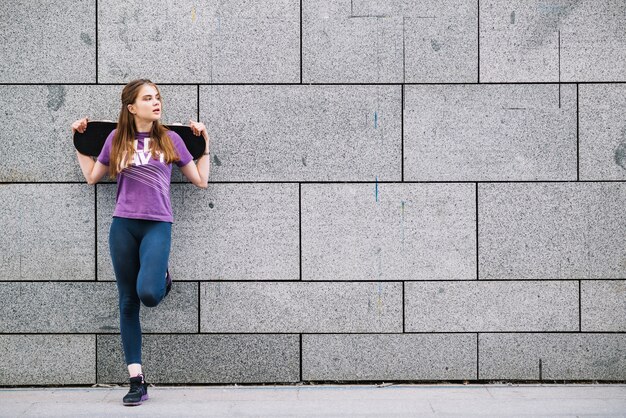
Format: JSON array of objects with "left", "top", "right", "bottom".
[{"left": 0, "top": 384, "right": 626, "bottom": 417}]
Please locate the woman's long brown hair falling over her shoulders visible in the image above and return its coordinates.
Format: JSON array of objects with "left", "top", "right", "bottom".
[{"left": 109, "top": 78, "right": 180, "bottom": 178}]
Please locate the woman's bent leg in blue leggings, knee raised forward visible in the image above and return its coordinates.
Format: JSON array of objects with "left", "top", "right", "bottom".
[{"left": 137, "top": 221, "right": 172, "bottom": 307}]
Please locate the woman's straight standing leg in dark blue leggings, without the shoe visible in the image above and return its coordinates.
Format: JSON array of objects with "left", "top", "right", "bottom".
[{"left": 109, "top": 218, "right": 141, "bottom": 365}]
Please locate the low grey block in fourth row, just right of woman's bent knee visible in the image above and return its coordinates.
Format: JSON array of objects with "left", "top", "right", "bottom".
[{"left": 200, "top": 282, "right": 402, "bottom": 333}]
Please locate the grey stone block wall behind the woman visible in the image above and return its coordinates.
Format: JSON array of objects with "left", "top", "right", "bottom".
[{"left": 0, "top": 0, "right": 626, "bottom": 386}]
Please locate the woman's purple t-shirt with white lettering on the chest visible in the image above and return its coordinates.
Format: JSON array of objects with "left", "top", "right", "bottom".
[{"left": 98, "top": 129, "right": 193, "bottom": 222}]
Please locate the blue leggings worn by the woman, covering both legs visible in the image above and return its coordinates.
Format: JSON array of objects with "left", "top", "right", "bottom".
[{"left": 109, "top": 217, "right": 172, "bottom": 365}]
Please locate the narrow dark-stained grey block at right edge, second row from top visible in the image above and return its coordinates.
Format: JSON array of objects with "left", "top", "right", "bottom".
[{"left": 579, "top": 84, "right": 626, "bottom": 180}]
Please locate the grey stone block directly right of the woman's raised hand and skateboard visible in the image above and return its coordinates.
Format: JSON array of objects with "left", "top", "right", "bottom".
[{"left": 200, "top": 85, "right": 402, "bottom": 181}]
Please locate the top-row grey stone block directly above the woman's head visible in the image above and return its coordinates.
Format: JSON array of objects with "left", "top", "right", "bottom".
[{"left": 98, "top": 0, "right": 300, "bottom": 83}]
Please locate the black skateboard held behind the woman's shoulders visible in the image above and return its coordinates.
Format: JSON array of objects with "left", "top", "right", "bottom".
[{"left": 74, "top": 120, "right": 206, "bottom": 160}]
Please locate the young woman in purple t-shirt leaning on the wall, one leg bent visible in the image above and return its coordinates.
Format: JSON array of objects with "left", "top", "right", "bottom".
[{"left": 72, "top": 79, "right": 210, "bottom": 405}]
